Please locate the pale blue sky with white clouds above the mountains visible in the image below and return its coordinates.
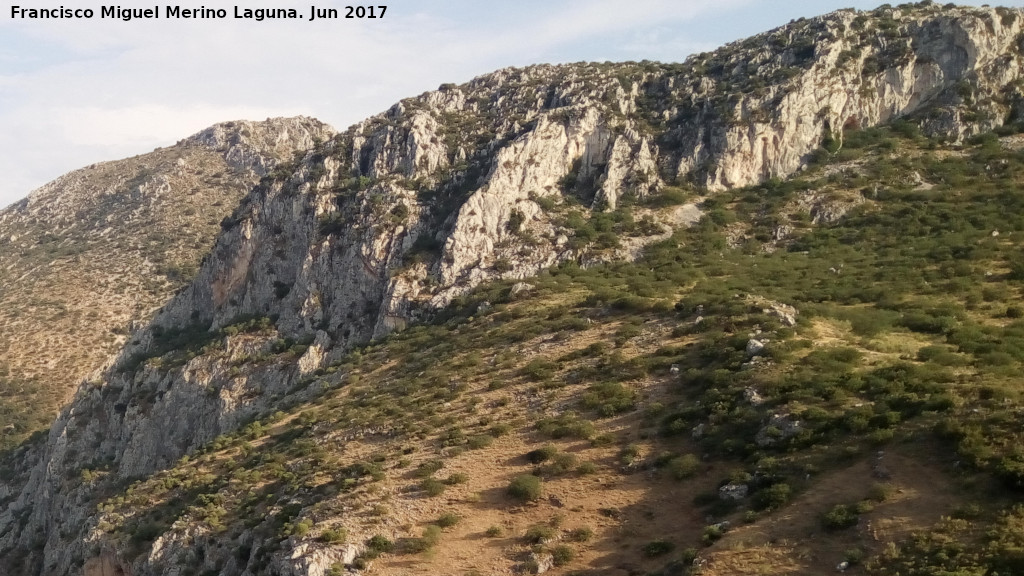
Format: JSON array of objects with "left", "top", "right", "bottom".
[{"left": 0, "top": 0, "right": 1024, "bottom": 207}]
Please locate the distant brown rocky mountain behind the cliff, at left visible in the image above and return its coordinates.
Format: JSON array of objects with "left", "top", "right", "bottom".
[{"left": 0, "top": 118, "right": 334, "bottom": 445}]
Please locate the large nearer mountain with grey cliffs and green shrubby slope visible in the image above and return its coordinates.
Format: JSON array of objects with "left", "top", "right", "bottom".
[{"left": 0, "top": 2, "right": 1024, "bottom": 576}]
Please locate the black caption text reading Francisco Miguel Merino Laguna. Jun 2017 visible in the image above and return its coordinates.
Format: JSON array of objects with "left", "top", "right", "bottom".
[{"left": 10, "top": 5, "right": 387, "bottom": 22}]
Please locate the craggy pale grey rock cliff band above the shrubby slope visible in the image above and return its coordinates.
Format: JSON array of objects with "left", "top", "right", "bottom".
[{"left": 0, "top": 5, "right": 1024, "bottom": 576}]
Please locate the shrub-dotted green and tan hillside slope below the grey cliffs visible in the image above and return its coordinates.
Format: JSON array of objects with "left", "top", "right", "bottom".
[{"left": 54, "top": 124, "right": 1024, "bottom": 576}]
